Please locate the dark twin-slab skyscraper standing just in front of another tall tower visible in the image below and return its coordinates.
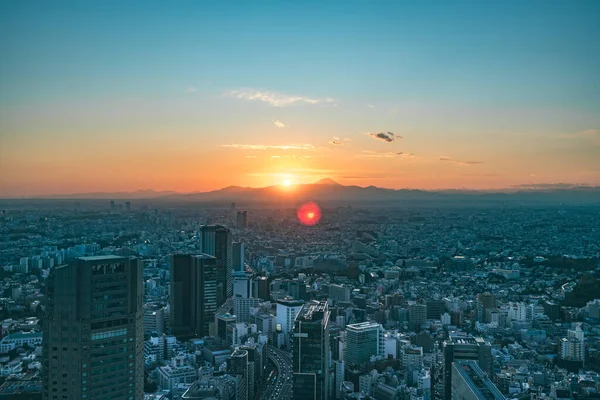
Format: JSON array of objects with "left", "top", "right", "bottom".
[{"left": 171, "top": 254, "right": 217, "bottom": 338}]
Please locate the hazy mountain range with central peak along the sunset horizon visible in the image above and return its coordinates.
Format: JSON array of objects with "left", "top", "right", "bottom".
[{"left": 8, "top": 178, "right": 600, "bottom": 204}]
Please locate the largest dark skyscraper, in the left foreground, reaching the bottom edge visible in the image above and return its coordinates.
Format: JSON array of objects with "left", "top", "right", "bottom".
[{"left": 42, "top": 256, "right": 144, "bottom": 400}]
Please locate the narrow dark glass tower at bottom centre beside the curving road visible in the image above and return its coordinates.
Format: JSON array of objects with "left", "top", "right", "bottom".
[{"left": 292, "top": 301, "right": 330, "bottom": 400}]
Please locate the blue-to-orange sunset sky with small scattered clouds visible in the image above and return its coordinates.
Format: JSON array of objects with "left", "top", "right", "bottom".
[{"left": 0, "top": 0, "right": 600, "bottom": 196}]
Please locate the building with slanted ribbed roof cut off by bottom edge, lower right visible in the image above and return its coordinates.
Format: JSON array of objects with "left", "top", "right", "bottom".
[{"left": 451, "top": 360, "right": 506, "bottom": 400}]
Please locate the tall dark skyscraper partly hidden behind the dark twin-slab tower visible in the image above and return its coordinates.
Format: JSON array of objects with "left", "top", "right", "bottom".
[{"left": 200, "top": 225, "right": 233, "bottom": 306}]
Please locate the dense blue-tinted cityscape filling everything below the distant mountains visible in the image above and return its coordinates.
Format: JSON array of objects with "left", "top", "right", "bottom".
[{"left": 0, "top": 200, "right": 600, "bottom": 400}]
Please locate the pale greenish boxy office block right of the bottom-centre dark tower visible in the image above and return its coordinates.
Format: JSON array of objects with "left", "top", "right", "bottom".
[{"left": 344, "top": 322, "right": 384, "bottom": 366}]
